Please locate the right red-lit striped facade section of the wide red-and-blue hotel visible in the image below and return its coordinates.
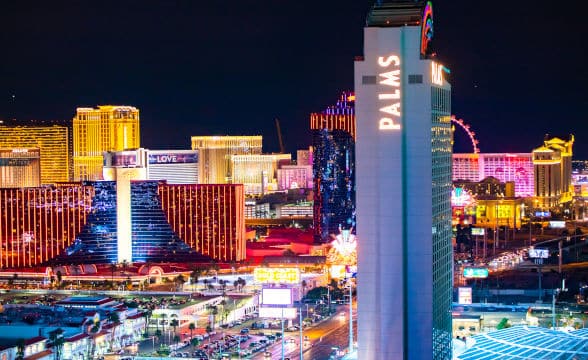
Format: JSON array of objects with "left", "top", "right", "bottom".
[{"left": 159, "top": 183, "right": 245, "bottom": 262}]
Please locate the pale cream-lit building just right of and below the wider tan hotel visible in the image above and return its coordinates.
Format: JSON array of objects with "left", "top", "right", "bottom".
[{"left": 230, "top": 154, "right": 292, "bottom": 195}]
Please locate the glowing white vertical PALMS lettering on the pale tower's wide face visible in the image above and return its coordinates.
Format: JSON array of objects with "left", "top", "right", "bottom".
[{"left": 378, "top": 55, "right": 402, "bottom": 130}]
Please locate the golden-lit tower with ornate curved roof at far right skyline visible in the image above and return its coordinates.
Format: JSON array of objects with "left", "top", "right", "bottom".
[{"left": 533, "top": 135, "right": 574, "bottom": 208}]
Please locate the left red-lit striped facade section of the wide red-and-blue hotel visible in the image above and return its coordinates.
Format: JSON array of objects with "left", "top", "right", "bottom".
[{"left": 0, "top": 184, "right": 94, "bottom": 268}]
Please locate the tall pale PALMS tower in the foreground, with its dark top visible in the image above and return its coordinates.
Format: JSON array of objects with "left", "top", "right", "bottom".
[{"left": 355, "top": 1, "right": 452, "bottom": 359}]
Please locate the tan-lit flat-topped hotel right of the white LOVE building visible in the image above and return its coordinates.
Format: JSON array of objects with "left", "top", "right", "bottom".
[{"left": 192, "top": 135, "right": 262, "bottom": 184}]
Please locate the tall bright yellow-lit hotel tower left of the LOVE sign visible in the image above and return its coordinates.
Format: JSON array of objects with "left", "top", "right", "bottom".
[{"left": 73, "top": 105, "right": 140, "bottom": 181}]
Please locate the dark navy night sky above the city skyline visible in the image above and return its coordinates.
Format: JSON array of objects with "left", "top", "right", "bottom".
[{"left": 0, "top": 0, "right": 588, "bottom": 159}]
